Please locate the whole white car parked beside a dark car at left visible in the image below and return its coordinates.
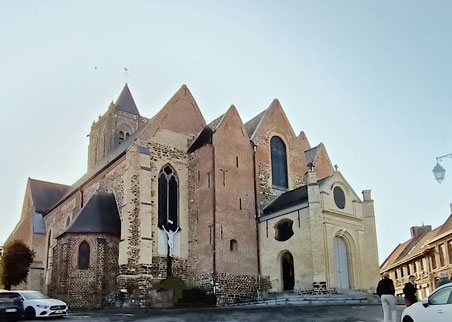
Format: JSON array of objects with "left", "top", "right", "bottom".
[{"left": 14, "top": 291, "right": 67, "bottom": 319}]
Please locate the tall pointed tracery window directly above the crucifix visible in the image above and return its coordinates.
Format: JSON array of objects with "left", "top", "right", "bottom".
[{"left": 158, "top": 165, "right": 179, "bottom": 231}]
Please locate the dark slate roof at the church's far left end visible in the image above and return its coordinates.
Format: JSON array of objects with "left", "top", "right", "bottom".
[{"left": 28, "top": 178, "right": 70, "bottom": 213}]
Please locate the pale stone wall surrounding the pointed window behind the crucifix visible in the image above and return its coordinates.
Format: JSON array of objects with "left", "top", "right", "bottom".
[{"left": 118, "top": 139, "right": 189, "bottom": 298}]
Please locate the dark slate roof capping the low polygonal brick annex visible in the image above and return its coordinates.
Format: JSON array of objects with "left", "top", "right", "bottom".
[{"left": 60, "top": 191, "right": 121, "bottom": 237}]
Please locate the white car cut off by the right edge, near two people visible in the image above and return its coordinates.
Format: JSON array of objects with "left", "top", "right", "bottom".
[{"left": 402, "top": 283, "right": 452, "bottom": 322}]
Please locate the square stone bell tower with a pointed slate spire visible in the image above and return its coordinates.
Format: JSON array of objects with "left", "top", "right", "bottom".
[{"left": 88, "top": 83, "right": 146, "bottom": 170}]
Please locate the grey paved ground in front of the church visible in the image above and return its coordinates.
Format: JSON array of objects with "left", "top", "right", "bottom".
[{"left": 54, "top": 305, "right": 404, "bottom": 322}]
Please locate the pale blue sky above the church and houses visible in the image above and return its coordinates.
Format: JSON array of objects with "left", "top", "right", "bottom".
[{"left": 0, "top": 1, "right": 452, "bottom": 260}]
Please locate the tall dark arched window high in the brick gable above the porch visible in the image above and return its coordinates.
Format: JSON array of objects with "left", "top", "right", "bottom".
[{"left": 270, "top": 136, "right": 288, "bottom": 189}]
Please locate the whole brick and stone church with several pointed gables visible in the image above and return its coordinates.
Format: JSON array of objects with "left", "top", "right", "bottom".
[{"left": 8, "top": 84, "right": 379, "bottom": 308}]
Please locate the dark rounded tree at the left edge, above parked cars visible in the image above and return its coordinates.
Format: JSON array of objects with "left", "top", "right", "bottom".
[{"left": 2, "top": 240, "right": 35, "bottom": 290}]
